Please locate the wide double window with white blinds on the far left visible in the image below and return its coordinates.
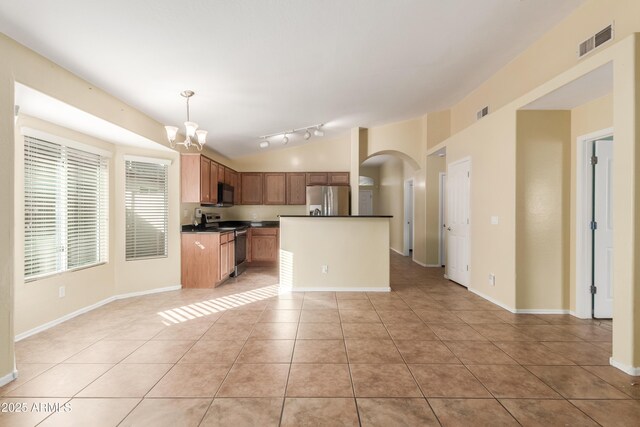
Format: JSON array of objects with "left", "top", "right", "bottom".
[{"left": 24, "top": 136, "right": 109, "bottom": 281}]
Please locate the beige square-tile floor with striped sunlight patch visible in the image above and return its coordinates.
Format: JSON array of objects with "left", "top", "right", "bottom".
[{"left": 0, "top": 254, "right": 640, "bottom": 427}]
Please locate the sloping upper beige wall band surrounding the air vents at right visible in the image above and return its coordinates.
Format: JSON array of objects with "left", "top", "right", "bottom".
[{"left": 451, "top": 0, "right": 640, "bottom": 133}]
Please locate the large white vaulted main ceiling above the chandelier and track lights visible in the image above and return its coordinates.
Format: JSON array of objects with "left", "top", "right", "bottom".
[{"left": 0, "top": 0, "right": 583, "bottom": 157}]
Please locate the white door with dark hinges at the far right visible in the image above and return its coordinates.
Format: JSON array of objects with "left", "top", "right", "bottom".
[{"left": 593, "top": 140, "right": 613, "bottom": 318}]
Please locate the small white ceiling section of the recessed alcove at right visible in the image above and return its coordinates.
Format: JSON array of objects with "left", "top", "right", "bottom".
[{"left": 522, "top": 62, "right": 613, "bottom": 110}]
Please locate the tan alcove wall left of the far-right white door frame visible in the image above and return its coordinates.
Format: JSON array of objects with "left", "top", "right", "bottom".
[{"left": 516, "top": 111, "right": 571, "bottom": 310}]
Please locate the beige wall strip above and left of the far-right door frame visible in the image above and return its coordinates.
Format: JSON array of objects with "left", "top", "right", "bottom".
[{"left": 569, "top": 94, "right": 613, "bottom": 312}]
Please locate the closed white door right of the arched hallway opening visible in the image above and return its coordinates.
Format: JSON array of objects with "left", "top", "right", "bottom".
[{"left": 446, "top": 160, "right": 471, "bottom": 286}]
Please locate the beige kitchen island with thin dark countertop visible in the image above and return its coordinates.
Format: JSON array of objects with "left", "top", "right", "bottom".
[{"left": 280, "top": 215, "right": 391, "bottom": 292}]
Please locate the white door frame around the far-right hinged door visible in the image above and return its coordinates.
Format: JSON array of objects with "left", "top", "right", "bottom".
[{"left": 573, "top": 127, "right": 615, "bottom": 319}]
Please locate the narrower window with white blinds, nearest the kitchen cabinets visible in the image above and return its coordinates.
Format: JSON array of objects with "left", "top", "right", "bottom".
[{"left": 125, "top": 157, "right": 169, "bottom": 261}]
